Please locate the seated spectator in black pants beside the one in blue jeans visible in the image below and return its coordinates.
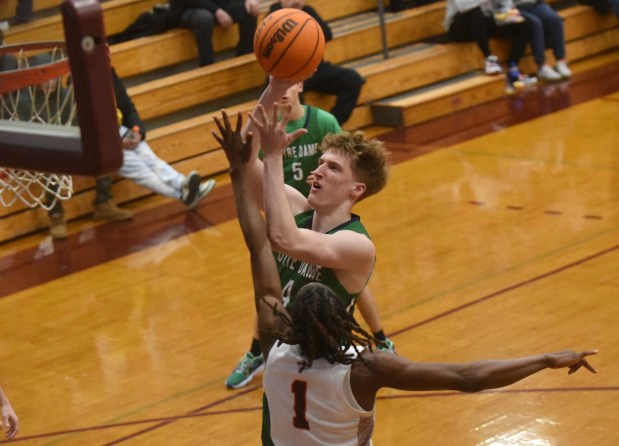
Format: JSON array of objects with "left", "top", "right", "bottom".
[{"left": 444, "top": 0, "right": 537, "bottom": 86}]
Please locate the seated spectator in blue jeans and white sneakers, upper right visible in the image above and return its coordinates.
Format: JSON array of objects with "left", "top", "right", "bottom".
[{"left": 515, "top": 0, "right": 572, "bottom": 82}]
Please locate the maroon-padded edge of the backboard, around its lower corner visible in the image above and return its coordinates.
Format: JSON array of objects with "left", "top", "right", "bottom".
[{"left": 0, "top": 0, "right": 122, "bottom": 176}]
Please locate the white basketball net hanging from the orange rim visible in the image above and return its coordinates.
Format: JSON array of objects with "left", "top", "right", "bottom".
[{"left": 0, "top": 42, "right": 77, "bottom": 210}]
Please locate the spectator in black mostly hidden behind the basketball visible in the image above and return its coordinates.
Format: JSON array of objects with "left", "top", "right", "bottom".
[{"left": 269, "top": 0, "right": 365, "bottom": 125}]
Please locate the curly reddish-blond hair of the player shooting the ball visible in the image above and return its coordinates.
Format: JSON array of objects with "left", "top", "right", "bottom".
[{"left": 320, "top": 130, "right": 390, "bottom": 200}]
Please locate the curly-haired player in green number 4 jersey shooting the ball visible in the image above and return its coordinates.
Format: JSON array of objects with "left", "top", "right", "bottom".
[{"left": 213, "top": 100, "right": 388, "bottom": 445}]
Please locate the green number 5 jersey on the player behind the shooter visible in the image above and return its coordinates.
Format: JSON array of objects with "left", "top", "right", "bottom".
[{"left": 284, "top": 105, "right": 342, "bottom": 197}]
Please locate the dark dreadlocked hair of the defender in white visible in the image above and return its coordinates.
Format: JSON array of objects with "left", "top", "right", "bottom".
[{"left": 262, "top": 283, "right": 377, "bottom": 372}]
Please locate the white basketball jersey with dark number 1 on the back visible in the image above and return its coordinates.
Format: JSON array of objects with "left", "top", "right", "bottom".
[{"left": 262, "top": 343, "right": 374, "bottom": 446}]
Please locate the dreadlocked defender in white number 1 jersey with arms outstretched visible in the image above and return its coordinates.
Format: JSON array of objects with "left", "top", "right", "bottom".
[{"left": 218, "top": 109, "right": 597, "bottom": 446}]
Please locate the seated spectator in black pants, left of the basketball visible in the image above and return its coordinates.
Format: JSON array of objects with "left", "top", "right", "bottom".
[{"left": 170, "top": 0, "right": 260, "bottom": 67}]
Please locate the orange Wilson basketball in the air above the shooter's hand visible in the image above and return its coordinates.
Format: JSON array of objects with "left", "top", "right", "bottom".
[{"left": 254, "top": 8, "right": 325, "bottom": 82}]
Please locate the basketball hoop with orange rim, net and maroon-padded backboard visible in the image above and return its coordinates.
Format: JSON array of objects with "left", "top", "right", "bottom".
[{"left": 0, "top": 0, "right": 123, "bottom": 211}]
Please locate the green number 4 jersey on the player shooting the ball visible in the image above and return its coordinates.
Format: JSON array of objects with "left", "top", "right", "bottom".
[{"left": 273, "top": 210, "right": 369, "bottom": 313}]
